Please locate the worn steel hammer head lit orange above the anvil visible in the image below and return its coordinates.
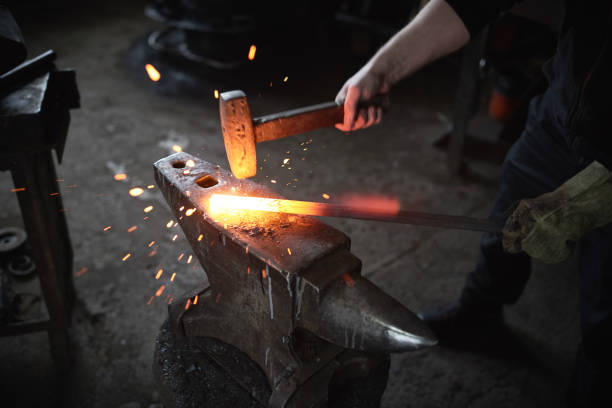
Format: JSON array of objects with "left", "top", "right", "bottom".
[{"left": 219, "top": 90, "right": 257, "bottom": 179}]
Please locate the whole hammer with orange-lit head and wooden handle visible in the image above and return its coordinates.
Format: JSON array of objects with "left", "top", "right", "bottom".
[{"left": 219, "top": 90, "right": 388, "bottom": 179}]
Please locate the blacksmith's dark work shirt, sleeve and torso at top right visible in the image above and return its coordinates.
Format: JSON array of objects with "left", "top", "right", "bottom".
[{"left": 447, "top": 0, "right": 612, "bottom": 169}]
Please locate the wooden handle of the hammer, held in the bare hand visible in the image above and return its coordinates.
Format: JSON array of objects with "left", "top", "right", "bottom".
[{"left": 253, "top": 95, "right": 388, "bottom": 143}]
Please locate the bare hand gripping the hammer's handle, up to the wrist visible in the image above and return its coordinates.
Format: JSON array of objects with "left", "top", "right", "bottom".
[{"left": 336, "top": 64, "right": 389, "bottom": 132}]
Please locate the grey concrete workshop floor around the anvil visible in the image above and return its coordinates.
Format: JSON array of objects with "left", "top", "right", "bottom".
[{"left": 0, "top": 3, "right": 578, "bottom": 408}]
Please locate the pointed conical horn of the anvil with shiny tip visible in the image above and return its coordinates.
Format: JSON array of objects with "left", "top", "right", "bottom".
[{"left": 297, "top": 250, "right": 437, "bottom": 353}]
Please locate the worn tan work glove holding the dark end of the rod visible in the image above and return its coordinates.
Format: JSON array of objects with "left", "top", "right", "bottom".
[{"left": 503, "top": 162, "right": 612, "bottom": 263}]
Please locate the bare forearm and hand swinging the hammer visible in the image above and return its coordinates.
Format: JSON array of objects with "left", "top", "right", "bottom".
[{"left": 336, "top": 0, "right": 470, "bottom": 132}]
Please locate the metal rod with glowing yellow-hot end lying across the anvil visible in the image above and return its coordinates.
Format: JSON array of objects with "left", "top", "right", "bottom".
[{"left": 209, "top": 194, "right": 504, "bottom": 233}]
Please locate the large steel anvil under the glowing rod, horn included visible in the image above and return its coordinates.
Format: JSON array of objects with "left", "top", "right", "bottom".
[{"left": 154, "top": 152, "right": 436, "bottom": 407}]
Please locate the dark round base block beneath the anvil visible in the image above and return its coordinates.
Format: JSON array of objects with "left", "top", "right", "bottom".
[{"left": 153, "top": 291, "right": 389, "bottom": 408}]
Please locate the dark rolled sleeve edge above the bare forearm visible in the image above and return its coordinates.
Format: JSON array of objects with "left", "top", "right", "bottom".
[{"left": 446, "top": 0, "right": 521, "bottom": 37}]
